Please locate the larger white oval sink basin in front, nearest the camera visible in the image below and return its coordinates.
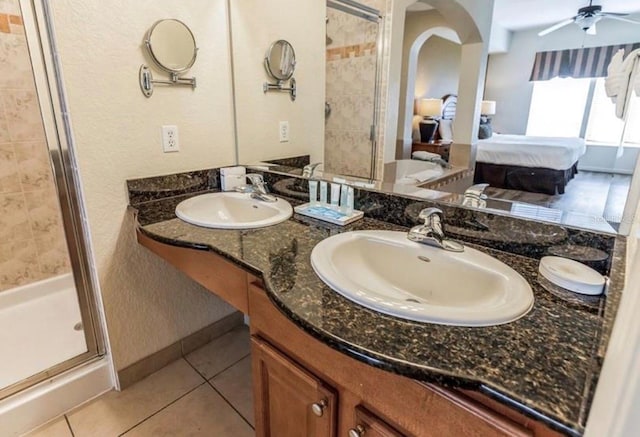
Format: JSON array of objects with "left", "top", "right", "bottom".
[{"left": 311, "top": 231, "right": 533, "bottom": 326}]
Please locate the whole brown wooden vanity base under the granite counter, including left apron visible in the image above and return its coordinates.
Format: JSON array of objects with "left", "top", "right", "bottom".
[{"left": 138, "top": 232, "right": 560, "bottom": 437}]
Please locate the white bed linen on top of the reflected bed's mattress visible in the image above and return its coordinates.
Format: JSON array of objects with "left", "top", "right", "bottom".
[{"left": 476, "top": 134, "right": 587, "bottom": 170}]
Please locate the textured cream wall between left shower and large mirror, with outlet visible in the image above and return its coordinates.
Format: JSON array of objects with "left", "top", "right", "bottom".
[{"left": 51, "top": 0, "right": 238, "bottom": 369}]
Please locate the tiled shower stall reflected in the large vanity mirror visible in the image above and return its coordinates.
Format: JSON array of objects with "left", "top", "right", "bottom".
[{"left": 324, "top": 0, "right": 385, "bottom": 179}]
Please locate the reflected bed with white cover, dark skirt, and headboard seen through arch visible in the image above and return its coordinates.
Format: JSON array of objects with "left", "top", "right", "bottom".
[{"left": 439, "top": 94, "right": 586, "bottom": 195}]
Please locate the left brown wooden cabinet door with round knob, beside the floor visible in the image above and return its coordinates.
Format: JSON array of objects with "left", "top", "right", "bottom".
[{"left": 251, "top": 337, "right": 337, "bottom": 437}]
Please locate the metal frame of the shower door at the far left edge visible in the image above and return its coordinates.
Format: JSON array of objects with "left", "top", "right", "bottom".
[{"left": 0, "top": 0, "right": 106, "bottom": 400}]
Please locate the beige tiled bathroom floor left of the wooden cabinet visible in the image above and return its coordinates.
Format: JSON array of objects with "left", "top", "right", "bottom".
[{"left": 27, "top": 326, "right": 255, "bottom": 437}]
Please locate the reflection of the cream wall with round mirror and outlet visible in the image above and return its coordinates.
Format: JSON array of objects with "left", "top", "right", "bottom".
[{"left": 230, "top": 0, "right": 326, "bottom": 163}]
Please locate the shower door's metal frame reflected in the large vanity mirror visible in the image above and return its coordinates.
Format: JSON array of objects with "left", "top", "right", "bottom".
[{"left": 327, "top": 0, "right": 385, "bottom": 180}]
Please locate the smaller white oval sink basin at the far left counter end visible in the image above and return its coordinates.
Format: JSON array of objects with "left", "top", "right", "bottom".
[{"left": 176, "top": 192, "right": 293, "bottom": 229}]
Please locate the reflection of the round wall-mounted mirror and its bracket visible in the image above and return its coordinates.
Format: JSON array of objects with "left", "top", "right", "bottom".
[{"left": 262, "top": 39, "right": 297, "bottom": 101}]
